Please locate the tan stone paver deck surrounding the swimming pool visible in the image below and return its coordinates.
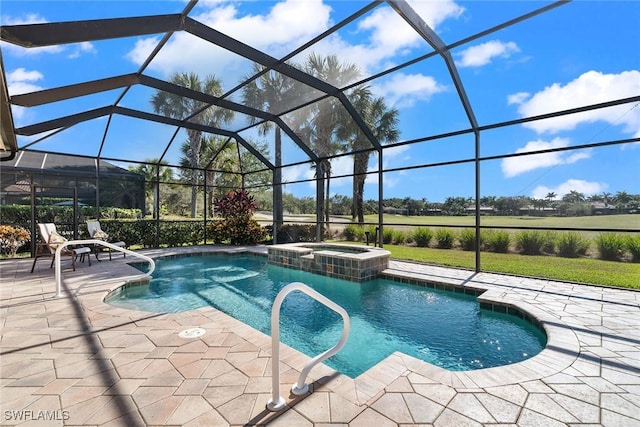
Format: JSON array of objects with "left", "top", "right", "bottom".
[{"left": 0, "top": 246, "right": 640, "bottom": 427}]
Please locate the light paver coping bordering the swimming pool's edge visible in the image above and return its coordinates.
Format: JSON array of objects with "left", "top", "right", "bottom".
[{"left": 94, "top": 247, "right": 580, "bottom": 405}]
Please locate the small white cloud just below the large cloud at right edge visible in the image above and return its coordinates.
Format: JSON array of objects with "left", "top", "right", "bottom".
[{"left": 501, "top": 138, "right": 590, "bottom": 178}]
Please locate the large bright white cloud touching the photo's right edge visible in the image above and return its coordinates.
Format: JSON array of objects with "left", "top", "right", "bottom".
[{"left": 509, "top": 70, "right": 640, "bottom": 137}]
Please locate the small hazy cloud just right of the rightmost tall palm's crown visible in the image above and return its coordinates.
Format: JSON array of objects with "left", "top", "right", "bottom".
[{"left": 373, "top": 73, "right": 447, "bottom": 108}]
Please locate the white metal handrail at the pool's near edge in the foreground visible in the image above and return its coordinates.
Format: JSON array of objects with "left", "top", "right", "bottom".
[{"left": 267, "top": 282, "right": 351, "bottom": 411}]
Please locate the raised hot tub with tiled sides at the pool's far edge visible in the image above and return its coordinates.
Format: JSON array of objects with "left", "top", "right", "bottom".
[{"left": 268, "top": 243, "right": 391, "bottom": 282}]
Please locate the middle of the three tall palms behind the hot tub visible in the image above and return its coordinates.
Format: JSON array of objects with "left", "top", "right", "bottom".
[{"left": 299, "top": 53, "right": 360, "bottom": 232}]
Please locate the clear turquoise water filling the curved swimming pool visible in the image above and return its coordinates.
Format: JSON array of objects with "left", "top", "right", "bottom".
[{"left": 106, "top": 254, "right": 546, "bottom": 378}]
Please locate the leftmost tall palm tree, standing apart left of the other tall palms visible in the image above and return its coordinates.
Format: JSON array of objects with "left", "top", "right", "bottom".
[{"left": 151, "top": 73, "right": 233, "bottom": 218}]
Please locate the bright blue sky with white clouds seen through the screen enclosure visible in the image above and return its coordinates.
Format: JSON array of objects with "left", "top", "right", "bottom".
[{"left": 0, "top": 0, "right": 640, "bottom": 202}]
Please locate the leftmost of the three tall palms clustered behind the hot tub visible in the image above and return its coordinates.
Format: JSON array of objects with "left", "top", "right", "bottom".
[{"left": 242, "top": 64, "right": 296, "bottom": 226}]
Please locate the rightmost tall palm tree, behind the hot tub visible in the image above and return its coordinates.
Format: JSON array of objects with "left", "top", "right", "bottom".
[{"left": 338, "top": 86, "right": 399, "bottom": 224}]
